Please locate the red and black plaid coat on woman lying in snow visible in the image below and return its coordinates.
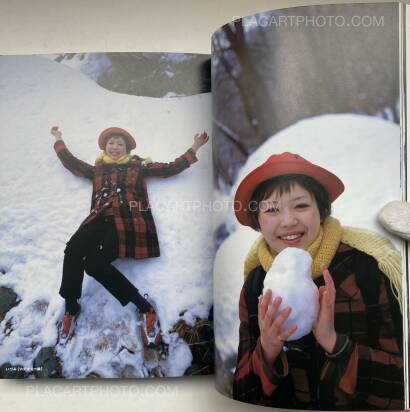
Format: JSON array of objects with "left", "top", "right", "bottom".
[{"left": 54, "top": 140, "right": 197, "bottom": 259}]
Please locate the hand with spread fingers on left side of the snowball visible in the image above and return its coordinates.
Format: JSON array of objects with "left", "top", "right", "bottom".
[{"left": 258, "top": 289, "right": 297, "bottom": 366}]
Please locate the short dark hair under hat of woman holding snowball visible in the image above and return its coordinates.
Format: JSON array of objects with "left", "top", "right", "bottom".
[{"left": 248, "top": 174, "right": 332, "bottom": 230}]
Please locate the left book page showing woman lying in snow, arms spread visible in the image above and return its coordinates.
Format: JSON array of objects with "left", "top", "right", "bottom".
[{"left": 0, "top": 53, "right": 213, "bottom": 379}]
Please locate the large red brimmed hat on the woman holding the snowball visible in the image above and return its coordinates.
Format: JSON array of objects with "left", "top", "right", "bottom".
[{"left": 234, "top": 152, "right": 344, "bottom": 226}]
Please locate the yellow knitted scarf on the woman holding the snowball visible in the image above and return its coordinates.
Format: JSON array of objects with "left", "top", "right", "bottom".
[{"left": 244, "top": 216, "right": 403, "bottom": 313}]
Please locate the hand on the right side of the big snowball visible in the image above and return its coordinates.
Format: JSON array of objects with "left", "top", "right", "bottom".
[{"left": 313, "top": 265, "right": 337, "bottom": 353}]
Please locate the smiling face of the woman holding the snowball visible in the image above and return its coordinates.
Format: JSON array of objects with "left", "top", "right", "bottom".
[{"left": 258, "top": 183, "right": 320, "bottom": 253}]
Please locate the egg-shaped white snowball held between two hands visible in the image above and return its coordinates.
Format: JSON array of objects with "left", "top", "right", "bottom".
[{"left": 263, "top": 247, "right": 319, "bottom": 341}]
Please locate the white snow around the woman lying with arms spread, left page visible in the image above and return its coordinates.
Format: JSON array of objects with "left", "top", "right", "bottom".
[{"left": 0, "top": 56, "right": 213, "bottom": 378}]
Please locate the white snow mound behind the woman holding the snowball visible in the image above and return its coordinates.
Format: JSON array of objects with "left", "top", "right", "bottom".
[{"left": 214, "top": 114, "right": 402, "bottom": 359}]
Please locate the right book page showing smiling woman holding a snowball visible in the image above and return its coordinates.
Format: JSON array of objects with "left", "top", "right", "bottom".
[{"left": 212, "top": 4, "right": 407, "bottom": 410}]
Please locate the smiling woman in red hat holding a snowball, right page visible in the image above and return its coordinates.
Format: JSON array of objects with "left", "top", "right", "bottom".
[{"left": 233, "top": 152, "right": 404, "bottom": 410}]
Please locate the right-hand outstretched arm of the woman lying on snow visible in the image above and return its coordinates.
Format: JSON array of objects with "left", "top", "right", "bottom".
[{"left": 142, "top": 132, "right": 209, "bottom": 177}]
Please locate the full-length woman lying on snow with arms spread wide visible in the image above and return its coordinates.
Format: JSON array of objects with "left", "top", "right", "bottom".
[{"left": 51, "top": 126, "right": 208, "bottom": 347}]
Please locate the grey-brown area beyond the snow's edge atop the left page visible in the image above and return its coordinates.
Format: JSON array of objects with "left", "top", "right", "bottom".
[{"left": 39, "top": 52, "right": 211, "bottom": 97}]
